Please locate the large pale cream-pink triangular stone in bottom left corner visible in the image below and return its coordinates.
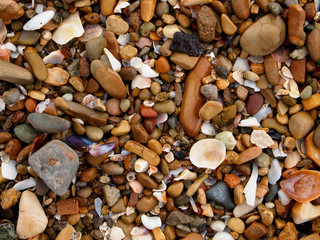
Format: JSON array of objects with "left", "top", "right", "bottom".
[{"left": 16, "top": 191, "right": 48, "bottom": 239}]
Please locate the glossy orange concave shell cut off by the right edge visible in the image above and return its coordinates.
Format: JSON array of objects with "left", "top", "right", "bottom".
[{"left": 280, "top": 170, "right": 320, "bottom": 203}]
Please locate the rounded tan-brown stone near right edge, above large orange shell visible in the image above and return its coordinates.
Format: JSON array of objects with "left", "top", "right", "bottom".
[{"left": 289, "top": 111, "right": 314, "bottom": 139}]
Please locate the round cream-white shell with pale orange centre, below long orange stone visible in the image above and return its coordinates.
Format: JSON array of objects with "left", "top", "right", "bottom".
[{"left": 190, "top": 138, "right": 226, "bottom": 170}]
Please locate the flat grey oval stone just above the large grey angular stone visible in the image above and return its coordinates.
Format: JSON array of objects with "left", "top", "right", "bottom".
[{"left": 28, "top": 113, "right": 71, "bottom": 133}]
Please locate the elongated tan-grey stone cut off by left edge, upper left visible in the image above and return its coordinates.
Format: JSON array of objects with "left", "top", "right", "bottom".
[{"left": 0, "top": 60, "right": 34, "bottom": 85}]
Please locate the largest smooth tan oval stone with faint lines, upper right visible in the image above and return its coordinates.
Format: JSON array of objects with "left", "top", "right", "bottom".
[{"left": 240, "top": 14, "right": 286, "bottom": 56}]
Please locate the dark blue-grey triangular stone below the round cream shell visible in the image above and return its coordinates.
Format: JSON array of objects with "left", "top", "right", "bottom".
[{"left": 206, "top": 181, "right": 236, "bottom": 210}]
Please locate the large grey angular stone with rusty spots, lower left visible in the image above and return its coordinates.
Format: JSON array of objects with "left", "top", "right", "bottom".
[{"left": 29, "top": 140, "right": 79, "bottom": 195}]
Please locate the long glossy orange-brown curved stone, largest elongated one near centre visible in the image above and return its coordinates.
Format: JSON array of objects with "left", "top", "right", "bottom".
[{"left": 180, "top": 57, "right": 211, "bottom": 137}]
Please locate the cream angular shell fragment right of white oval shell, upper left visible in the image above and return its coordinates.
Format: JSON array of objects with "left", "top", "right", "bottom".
[{"left": 52, "top": 11, "right": 84, "bottom": 45}]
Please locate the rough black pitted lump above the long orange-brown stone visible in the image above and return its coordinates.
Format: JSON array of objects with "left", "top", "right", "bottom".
[{"left": 170, "top": 32, "right": 204, "bottom": 57}]
